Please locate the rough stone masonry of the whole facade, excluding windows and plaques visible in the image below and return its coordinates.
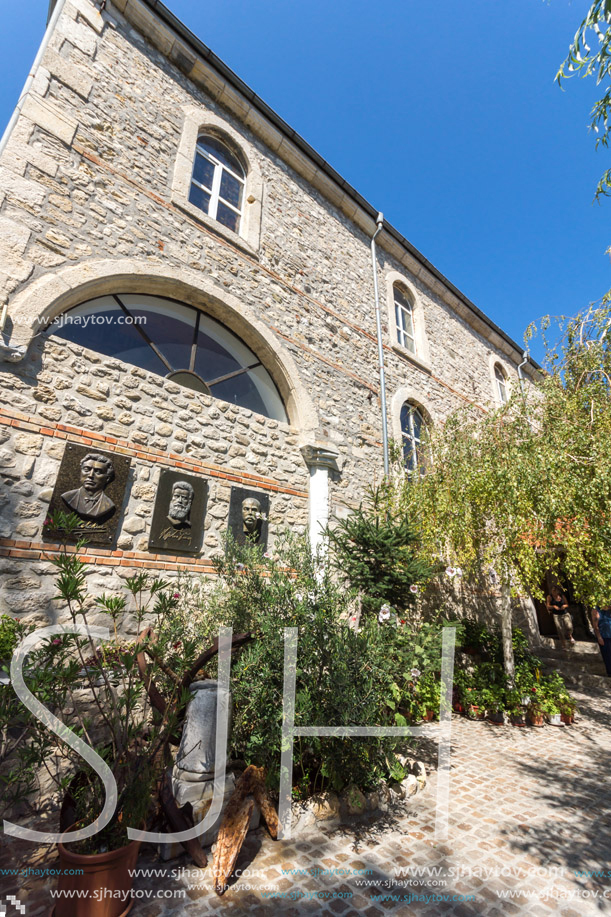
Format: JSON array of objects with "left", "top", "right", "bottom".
[{"left": 0, "top": 0, "right": 532, "bottom": 624}]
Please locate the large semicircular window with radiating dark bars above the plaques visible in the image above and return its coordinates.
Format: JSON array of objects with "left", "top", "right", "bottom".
[{"left": 51, "top": 293, "right": 287, "bottom": 421}]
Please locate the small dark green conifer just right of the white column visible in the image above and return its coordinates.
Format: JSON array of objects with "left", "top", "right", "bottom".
[{"left": 325, "top": 483, "right": 434, "bottom": 613}]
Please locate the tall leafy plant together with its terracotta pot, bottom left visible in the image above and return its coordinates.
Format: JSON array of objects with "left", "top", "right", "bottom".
[{"left": 4, "top": 514, "right": 189, "bottom": 917}]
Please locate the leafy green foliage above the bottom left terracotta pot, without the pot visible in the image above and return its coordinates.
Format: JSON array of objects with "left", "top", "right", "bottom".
[{"left": 0, "top": 514, "right": 189, "bottom": 853}]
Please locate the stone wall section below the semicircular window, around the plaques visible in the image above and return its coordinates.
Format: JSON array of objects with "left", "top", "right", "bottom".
[{"left": 0, "top": 339, "right": 308, "bottom": 621}]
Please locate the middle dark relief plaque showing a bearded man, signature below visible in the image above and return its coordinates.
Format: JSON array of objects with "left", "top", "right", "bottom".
[{"left": 149, "top": 468, "right": 208, "bottom": 554}]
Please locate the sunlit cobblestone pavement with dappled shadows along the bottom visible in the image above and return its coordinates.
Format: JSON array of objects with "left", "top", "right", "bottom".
[{"left": 1, "top": 680, "right": 611, "bottom": 917}]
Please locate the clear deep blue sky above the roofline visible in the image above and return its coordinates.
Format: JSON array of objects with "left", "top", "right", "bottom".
[{"left": 0, "top": 0, "right": 611, "bottom": 358}]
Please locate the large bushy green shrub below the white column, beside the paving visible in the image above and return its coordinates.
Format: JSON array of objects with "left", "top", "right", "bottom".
[{"left": 206, "top": 537, "right": 414, "bottom": 795}]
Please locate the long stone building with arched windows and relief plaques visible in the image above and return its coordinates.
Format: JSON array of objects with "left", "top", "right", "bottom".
[{"left": 0, "top": 0, "right": 533, "bottom": 621}]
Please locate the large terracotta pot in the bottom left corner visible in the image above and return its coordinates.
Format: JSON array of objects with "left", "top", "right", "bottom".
[{"left": 51, "top": 829, "right": 140, "bottom": 917}]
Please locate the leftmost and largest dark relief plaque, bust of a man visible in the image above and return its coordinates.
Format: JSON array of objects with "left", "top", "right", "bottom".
[{"left": 43, "top": 443, "right": 131, "bottom": 546}]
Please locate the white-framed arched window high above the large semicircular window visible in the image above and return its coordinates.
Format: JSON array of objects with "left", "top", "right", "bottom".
[{"left": 189, "top": 134, "right": 246, "bottom": 233}]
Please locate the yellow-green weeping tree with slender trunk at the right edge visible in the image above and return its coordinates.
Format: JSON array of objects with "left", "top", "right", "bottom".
[{"left": 399, "top": 307, "right": 611, "bottom": 678}]
